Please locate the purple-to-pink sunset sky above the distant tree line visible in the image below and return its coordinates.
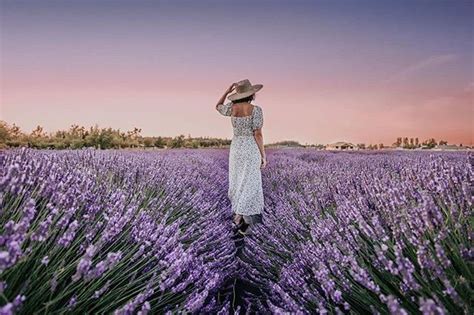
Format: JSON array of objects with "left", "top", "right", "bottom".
[{"left": 0, "top": 0, "right": 474, "bottom": 145}]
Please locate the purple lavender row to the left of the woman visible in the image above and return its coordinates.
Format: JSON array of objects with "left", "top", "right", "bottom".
[{"left": 0, "top": 149, "right": 236, "bottom": 314}]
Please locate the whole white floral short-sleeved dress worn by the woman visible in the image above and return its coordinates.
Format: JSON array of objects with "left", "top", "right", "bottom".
[{"left": 217, "top": 102, "right": 264, "bottom": 221}]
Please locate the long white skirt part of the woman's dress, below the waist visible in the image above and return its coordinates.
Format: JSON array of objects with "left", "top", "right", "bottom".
[{"left": 228, "top": 135, "right": 264, "bottom": 223}]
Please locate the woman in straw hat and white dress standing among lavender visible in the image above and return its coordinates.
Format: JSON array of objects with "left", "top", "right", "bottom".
[{"left": 216, "top": 79, "right": 267, "bottom": 234}]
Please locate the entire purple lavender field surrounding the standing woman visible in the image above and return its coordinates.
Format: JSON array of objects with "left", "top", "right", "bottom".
[{"left": 0, "top": 149, "right": 474, "bottom": 314}]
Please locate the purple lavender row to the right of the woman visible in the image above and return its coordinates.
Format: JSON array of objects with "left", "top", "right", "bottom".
[{"left": 244, "top": 150, "right": 474, "bottom": 314}]
